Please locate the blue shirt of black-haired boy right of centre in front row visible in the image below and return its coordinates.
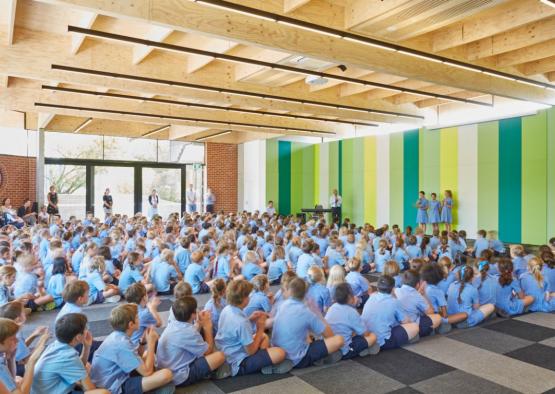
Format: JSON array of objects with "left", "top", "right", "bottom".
[{"left": 326, "top": 303, "right": 366, "bottom": 355}]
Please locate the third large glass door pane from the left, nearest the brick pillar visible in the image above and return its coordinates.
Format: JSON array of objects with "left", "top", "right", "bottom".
[{"left": 143, "top": 167, "right": 181, "bottom": 218}]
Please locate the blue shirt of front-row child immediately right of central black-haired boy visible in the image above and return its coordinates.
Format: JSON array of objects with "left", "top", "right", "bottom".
[{"left": 361, "top": 293, "right": 405, "bottom": 346}]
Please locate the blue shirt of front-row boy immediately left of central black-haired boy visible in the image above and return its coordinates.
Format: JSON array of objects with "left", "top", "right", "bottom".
[{"left": 272, "top": 298, "right": 326, "bottom": 365}]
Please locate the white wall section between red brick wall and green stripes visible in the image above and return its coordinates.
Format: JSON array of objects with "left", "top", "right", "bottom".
[{"left": 238, "top": 140, "right": 266, "bottom": 211}]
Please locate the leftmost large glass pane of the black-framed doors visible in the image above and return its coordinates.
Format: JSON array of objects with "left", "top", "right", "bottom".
[{"left": 44, "top": 164, "right": 86, "bottom": 219}]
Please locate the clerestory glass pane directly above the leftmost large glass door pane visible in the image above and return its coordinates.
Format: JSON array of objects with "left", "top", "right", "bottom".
[{"left": 44, "top": 132, "right": 102, "bottom": 159}]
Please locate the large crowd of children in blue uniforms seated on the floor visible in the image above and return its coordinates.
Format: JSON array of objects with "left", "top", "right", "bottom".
[{"left": 0, "top": 208, "right": 555, "bottom": 394}]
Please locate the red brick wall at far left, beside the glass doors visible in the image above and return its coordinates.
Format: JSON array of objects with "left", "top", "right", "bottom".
[{"left": 0, "top": 155, "right": 36, "bottom": 208}]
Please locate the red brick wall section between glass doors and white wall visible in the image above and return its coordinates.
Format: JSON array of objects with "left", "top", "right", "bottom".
[{"left": 204, "top": 142, "right": 239, "bottom": 212}]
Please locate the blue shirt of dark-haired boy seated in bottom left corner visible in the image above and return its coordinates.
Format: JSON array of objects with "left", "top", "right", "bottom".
[{"left": 31, "top": 340, "right": 87, "bottom": 394}]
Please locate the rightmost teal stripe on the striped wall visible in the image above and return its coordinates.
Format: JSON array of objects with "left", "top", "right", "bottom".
[{"left": 499, "top": 118, "right": 522, "bottom": 242}]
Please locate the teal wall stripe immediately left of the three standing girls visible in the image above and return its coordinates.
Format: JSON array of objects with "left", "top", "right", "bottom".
[{"left": 403, "top": 130, "right": 419, "bottom": 228}]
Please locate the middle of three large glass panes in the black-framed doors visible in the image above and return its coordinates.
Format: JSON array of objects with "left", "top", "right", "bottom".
[{"left": 94, "top": 166, "right": 135, "bottom": 217}]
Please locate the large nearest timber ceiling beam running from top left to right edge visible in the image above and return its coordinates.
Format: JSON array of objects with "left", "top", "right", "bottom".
[{"left": 35, "top": 0, "right": 555, "bottom": 104}]
